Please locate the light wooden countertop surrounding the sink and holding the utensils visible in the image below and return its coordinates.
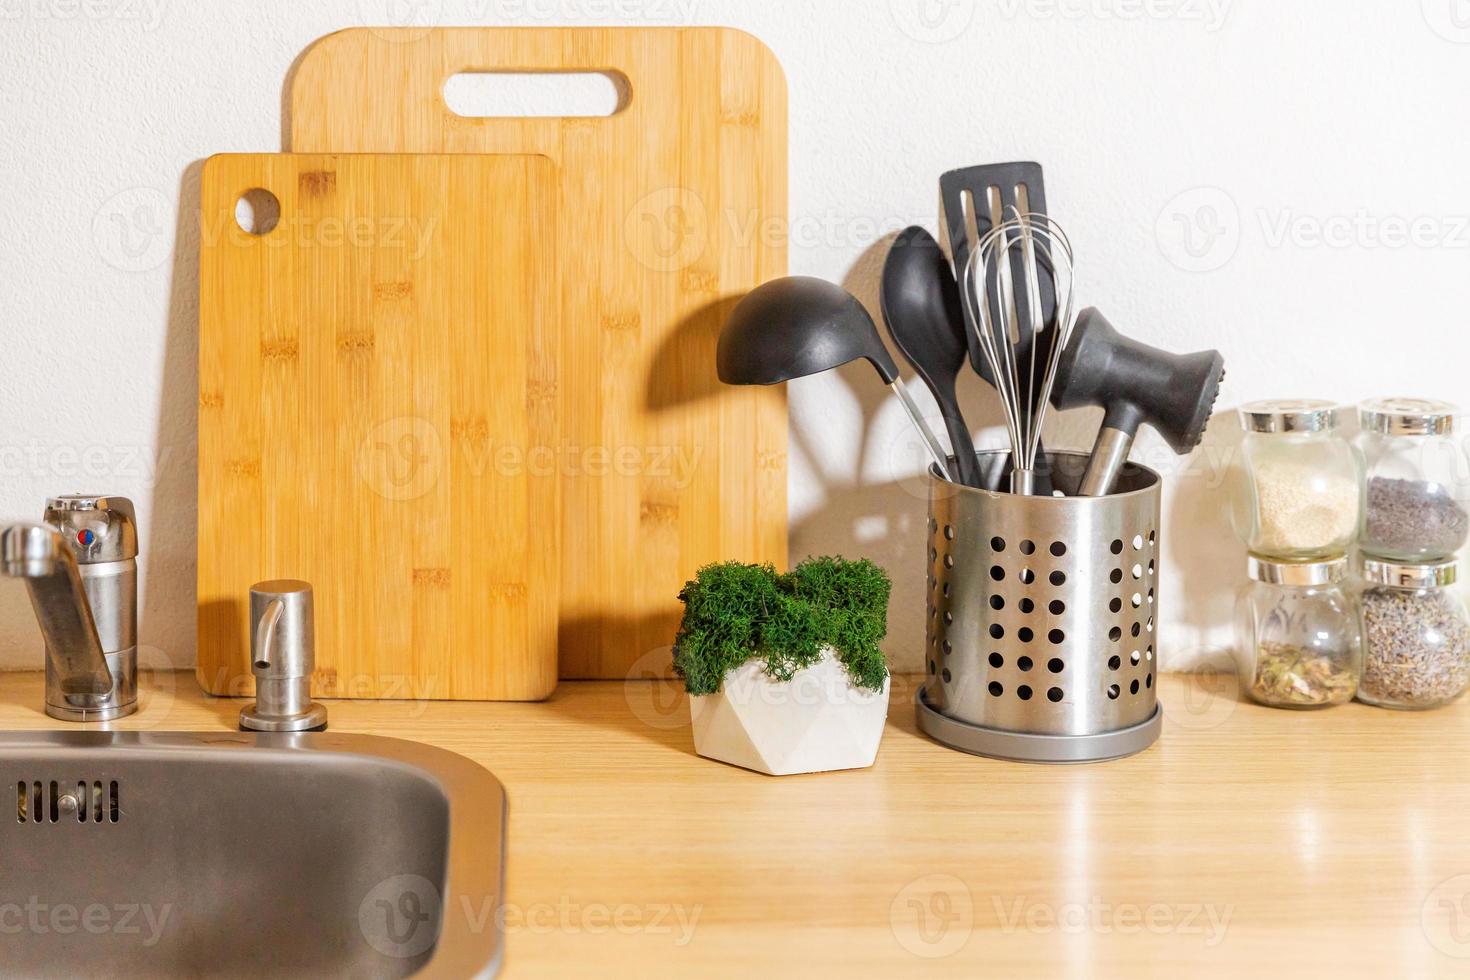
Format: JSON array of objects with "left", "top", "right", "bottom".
[{"left": 0, "top": 673, "right": 1470, "bottom": 979}]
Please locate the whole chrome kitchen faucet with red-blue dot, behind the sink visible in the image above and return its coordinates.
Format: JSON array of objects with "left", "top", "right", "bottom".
[{"left": 0, "top": 495, "right": 138, "bottom": 721}]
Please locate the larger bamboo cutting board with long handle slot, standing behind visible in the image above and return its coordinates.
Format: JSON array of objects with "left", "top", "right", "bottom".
[{"left": 291, "top": 28, "right": 788, "bottom": 679}]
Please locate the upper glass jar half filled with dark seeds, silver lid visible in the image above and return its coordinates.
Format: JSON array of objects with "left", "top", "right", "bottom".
[{"left": 1358, "top": 398, "right": 1470, "bottom": 563}]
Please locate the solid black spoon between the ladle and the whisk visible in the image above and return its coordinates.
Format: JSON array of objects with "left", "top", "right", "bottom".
[{"left": 882, "top": 225, "right": 982, "bottom": 486}]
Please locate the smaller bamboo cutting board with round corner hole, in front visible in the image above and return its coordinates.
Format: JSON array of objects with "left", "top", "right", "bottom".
[{"left": 198, "top": 154, "right": 563, "bottom": 699}]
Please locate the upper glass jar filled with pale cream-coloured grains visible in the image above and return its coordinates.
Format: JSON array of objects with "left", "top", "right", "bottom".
[{"left": 1232, "top": 400, "right": 1363, "bottom": 561}]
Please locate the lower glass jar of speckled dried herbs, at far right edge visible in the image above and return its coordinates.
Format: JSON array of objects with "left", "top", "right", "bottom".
[{"left": 1358, "top": 558, "right": 1470, "bottom": 708}]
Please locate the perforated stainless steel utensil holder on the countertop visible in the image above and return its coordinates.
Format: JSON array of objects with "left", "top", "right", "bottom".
[{"left": 917, "top": 453, "right": 1163, "bottom": 763}]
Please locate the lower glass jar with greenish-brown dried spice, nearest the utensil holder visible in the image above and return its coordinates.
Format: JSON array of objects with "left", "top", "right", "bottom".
[{"left": 1236, "top": 555, "right": 1363, "bottom": 708}]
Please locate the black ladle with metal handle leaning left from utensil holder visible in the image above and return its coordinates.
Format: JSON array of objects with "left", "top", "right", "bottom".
[{"left": 716, "top": 276, "right": 973, "bottom": 482}]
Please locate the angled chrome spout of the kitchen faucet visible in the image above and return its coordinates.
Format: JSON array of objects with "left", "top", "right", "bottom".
[{"left": 0, "top": 523, "right": 113, "bottom": 711}]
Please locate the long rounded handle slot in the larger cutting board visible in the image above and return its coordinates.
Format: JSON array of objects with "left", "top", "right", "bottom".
[{"left": 442, "top": 72, "right": 632, "bottom": 119}]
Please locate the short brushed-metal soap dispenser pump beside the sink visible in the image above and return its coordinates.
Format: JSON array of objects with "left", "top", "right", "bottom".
[{"left": 240, "top": 579, "right": 326, "bottom": 732}]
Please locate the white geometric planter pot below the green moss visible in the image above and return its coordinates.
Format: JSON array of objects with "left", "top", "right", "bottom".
[{"left": 689, "top": 649, "right": 889, "bottom": 776}]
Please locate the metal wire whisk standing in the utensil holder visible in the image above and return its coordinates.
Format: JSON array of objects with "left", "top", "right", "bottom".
[{"left": 960, "top": 207, "right": 1078, "bottom": 495}]
